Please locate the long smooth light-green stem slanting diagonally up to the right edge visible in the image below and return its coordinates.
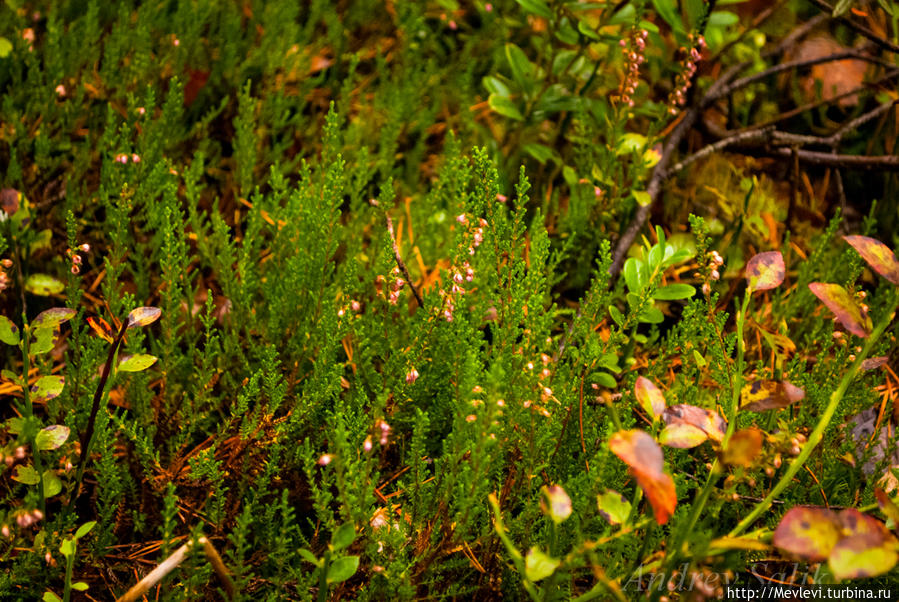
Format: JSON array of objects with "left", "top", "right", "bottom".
[{"left": 728, "top": 292, "right": 897, "bottom": 537}]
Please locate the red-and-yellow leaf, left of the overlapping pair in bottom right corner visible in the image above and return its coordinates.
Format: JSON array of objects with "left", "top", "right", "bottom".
[{"left": 772, "top": 506, "right": 842, "bottom": 562}]
